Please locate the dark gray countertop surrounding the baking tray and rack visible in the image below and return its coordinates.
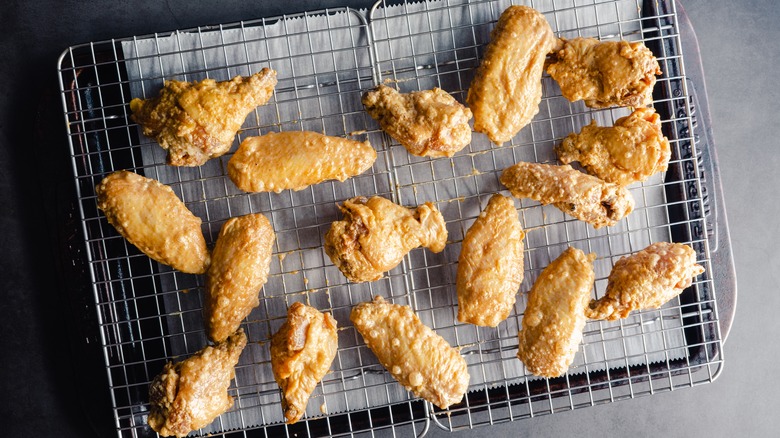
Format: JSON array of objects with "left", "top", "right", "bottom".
[{"left": 0, "top": 0, "right": 780, "bottom": 437}]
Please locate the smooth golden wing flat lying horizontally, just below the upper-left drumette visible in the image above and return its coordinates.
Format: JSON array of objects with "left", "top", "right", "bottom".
[{"left": 228, "top": 131, "right": 376, "bottom": 193}]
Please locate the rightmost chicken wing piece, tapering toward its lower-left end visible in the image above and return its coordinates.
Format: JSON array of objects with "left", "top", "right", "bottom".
[{"left": 585, "top": 242, "right": 704, "bottom": 320}]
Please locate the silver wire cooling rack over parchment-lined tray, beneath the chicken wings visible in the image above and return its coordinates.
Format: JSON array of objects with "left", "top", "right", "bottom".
[{"left": 59, "top": 0, "right": 722, "bottom": 436}]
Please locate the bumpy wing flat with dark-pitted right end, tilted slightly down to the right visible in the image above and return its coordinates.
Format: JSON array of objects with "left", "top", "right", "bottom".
[{"left": 500, "top": 162, "right": 634, "bottom": 228}]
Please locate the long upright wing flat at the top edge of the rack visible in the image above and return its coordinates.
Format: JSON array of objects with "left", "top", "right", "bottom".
[{"left": 466, "top": 6, "right": 555, "bottom": 145}]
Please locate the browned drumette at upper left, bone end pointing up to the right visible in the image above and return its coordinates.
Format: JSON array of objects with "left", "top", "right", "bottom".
[{"left": 130, "top": 68, "right": 276, "bottom": 166}]
